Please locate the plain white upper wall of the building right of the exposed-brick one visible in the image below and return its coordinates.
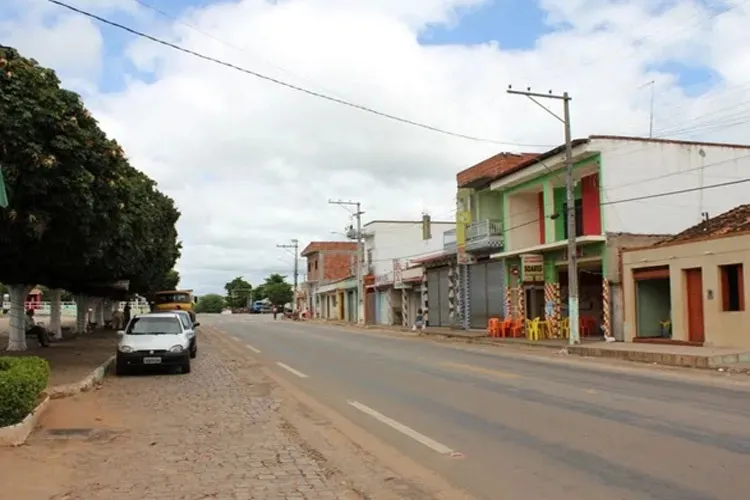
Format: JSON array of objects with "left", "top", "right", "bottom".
[{"left": 362, "top": 221, "right": 456, "bottom": 279}]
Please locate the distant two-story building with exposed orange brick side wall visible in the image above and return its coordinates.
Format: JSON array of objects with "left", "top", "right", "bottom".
[{"left": 300, "top": 241, "right": 357, "bottom": 319}]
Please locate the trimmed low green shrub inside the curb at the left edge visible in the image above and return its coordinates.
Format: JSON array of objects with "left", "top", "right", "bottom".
[{"left": 0, "top": 356, "right": 49, "bottom": 427}]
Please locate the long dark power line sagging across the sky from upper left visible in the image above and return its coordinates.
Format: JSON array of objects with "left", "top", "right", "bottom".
[{"left": 47, "top": 0, "right": 551, "bottom": 148}]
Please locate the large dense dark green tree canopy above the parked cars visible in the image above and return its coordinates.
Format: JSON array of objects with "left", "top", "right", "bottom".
[{"left": 0, "top": 45, "right": 181, "bottom": 294}]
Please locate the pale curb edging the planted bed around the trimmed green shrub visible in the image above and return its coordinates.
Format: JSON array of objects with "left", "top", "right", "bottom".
[{"left": 0, "top": 356, "right": 115, "bottom": 448}]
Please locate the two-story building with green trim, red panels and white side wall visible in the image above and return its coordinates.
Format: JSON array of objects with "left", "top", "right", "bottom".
[{"left": 484, "top": 136, "right": 750, "bottom": 339}]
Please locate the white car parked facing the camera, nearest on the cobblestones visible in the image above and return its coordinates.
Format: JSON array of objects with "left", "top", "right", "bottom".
[{"left": 115, "top": 312, "right": 191, "bottom": 375}]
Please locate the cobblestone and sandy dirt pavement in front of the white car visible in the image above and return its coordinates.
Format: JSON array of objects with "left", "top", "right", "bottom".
[{"left": 0, "top": 326, "right": 361, "bottom": 500}]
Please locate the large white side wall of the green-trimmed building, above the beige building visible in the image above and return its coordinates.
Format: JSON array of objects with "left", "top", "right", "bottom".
[{"left": 604, "top": 139, "right": 750, "bottom": 234}]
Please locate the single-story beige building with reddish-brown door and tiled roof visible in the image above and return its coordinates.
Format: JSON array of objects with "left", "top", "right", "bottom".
[{"left": 622, "top": 205, "right": 750, "bottom": 348}]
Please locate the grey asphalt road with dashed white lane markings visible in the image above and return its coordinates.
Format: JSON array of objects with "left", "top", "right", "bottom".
[{"left": 201, "top": 315, "right": 750, "bottom": 500}]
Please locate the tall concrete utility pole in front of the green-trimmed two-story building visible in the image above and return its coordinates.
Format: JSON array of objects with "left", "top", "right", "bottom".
[{"left": 508, "top": 85, "right": 581, "bottom": 344}]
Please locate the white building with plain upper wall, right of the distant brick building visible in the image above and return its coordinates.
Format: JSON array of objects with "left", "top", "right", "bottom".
[{"left": 362, "top": 220, "right": 456, "bottom": 326}]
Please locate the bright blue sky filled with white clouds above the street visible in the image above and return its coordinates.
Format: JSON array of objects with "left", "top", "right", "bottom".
[{"left": 0, "top": 0, "right": 750, "bottom": 294}]
